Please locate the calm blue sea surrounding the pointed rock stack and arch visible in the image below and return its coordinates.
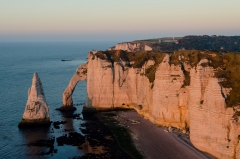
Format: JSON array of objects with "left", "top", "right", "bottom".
[{"left": 0, "top": 41, "right": 116, "bottom": 159}]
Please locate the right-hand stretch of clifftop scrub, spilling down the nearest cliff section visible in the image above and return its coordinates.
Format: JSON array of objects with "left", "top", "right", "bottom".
[{"left": 170, "top": 50, "right": 240, "bottom": 107}]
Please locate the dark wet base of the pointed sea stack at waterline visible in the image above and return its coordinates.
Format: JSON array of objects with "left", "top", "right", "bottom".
[{"left": 18, "top": 118, "right": 51, "bottom": 128}]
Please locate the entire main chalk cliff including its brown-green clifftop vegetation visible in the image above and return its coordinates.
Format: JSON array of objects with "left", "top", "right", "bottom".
[{"left": 64, "top": 50, "right": 240, "bottom": 158}]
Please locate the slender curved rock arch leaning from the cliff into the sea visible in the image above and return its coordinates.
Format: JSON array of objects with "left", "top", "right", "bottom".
[{"left": 59, "top": 64, "right": 87, "bottom": 110}]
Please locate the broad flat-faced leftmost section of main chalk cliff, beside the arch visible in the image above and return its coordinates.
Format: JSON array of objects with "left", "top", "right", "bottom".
[{"left": 86, "top": 53, "right": 151, "bottom": 109}]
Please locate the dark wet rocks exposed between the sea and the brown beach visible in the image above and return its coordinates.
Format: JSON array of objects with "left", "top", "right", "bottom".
[{"left": 45, "top": 112, "right": 135, "bottom": 159}]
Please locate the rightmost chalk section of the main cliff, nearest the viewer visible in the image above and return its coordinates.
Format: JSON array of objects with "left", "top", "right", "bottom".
[{"left": 189, "top": 66, "right": 240, "bottom": 158}]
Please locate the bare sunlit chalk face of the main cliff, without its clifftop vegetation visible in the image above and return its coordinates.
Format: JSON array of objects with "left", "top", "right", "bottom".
[{"left": 65, "top": 52, "right": 240, "bottom": 159}]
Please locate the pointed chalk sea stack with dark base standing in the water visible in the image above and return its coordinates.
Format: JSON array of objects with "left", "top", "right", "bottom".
[{"left": 18, "top": 72, "right": 50, "bottom": 127}]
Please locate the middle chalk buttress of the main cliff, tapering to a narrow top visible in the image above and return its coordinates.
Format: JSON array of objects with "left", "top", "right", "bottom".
[{"left": 149, "top": 55, "right": 184, "bottom": 127}]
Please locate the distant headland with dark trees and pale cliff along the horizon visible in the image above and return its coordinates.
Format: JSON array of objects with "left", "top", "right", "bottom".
[{"left": 109, "top": 35, "right": 240, "bottom": 52}]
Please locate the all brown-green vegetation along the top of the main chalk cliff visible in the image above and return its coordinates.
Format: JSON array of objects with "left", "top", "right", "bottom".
[{"left": 96, "top": 50, "right": 240, "bottom": 107}]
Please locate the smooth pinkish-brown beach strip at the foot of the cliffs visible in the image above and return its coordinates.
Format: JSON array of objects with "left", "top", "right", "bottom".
[{"left": 116, "top": 111, "right": 213, "bottom": 159}]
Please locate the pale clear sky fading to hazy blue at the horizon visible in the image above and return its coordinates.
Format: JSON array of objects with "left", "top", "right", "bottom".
[{"left": 0, "top": 0, "right": 240, "bottom": 41}]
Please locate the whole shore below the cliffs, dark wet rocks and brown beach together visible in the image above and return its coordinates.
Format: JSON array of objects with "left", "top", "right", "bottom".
[{"left": 16, "top": 110, "right": 214, "bottom": 159}]
